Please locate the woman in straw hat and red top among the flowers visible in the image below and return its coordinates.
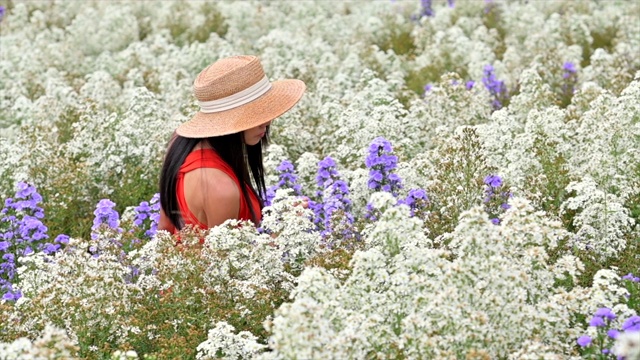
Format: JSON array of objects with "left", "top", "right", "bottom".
[{"left": 158, "top": 56, "right": 305, "bottom": 233}]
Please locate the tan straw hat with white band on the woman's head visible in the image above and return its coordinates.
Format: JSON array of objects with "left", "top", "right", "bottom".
[{"left": 176, "top": 56, "right": 305, "bottom": 138}]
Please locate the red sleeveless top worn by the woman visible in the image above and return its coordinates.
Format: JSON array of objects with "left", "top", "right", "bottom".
[{"left": 176, "top": 149, "right": 262, "bottom": 230}]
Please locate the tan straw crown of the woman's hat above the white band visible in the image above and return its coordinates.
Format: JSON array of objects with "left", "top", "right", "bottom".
[{"left": 193, "top": 55, "right": 265, "bottom": 101}]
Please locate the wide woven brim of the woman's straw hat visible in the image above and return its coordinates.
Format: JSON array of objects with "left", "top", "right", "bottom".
[{"left": 176, "top": 79, "right": 306, "bottom": 139}]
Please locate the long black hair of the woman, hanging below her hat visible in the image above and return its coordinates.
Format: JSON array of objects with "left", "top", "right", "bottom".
[{"left": 160, "top": 126, "right": 269, "bottom": 230}]
